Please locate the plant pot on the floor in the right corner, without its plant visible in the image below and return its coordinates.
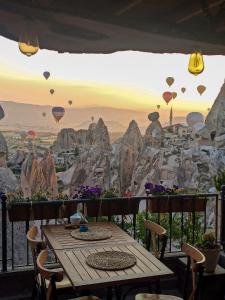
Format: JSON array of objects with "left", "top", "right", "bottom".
[{"left": 199, "top": 245, "right": 220, "bottom": 273}]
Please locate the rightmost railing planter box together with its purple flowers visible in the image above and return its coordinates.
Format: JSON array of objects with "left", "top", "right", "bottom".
[{"left": 145, "top": 182, "right": 207, "bottom": 213}]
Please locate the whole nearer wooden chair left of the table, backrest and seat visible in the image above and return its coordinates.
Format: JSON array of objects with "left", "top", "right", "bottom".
[{"left": 37, "top": 250, "right": 99, "bottom": 300}]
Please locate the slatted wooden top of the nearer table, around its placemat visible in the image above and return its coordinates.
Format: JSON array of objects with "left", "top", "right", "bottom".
[{"left": 55, "top": 241, "right": 173, "bottom": 290}]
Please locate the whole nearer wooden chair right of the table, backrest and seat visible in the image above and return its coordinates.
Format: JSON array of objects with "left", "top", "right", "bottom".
[{"left": 135, "top": 243, "right": 205, "bottom": 300}]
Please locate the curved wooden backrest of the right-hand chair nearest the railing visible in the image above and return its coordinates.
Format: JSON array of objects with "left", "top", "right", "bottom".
[{"left": 144, "top": 220, "right": 168, "bottom": 260}]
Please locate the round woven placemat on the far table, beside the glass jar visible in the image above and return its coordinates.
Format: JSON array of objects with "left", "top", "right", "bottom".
[{"left": 71, "top": 226, "right": 112, "bottom": 241}]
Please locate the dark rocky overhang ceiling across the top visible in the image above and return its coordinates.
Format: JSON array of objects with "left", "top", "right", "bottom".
[{"left": 0, "top": 0, "right": 225, "bottom": 55}]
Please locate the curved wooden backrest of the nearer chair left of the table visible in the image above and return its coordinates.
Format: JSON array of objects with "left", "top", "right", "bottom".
[{"left": 37, "top": 249, "right": 63, "bottom": 300}]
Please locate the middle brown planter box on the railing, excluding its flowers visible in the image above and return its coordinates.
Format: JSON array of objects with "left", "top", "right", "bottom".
[{"left": 86, "top": 198, "right": 140, "bottom": 217}]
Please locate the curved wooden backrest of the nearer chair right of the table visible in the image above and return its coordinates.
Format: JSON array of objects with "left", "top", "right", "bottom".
[{"left": 181, "top": 243, "right": 205, "bottom": 300}]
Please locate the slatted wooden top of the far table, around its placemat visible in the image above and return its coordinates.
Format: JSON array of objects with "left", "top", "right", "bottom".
[{"left": 42, "top": 222, "right": 134, "bottom": 250}]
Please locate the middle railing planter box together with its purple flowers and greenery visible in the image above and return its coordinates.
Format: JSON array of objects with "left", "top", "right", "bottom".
[{"left": 82, "top": 187, "right": 140, "bottom": 217}]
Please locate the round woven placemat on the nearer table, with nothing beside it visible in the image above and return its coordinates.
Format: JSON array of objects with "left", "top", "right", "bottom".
[{"left": 86, "top": 251, "right": 137, "bottom": 271}]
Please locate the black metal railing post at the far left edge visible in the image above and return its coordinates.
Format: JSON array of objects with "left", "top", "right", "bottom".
[{"left": 0, "top": 193, "right": 7, "bottom": 272}]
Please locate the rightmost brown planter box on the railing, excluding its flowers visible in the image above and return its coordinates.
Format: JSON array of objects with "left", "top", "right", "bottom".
[{"left": 148, "top": 195, "right": 207, "bottom": 213}]
